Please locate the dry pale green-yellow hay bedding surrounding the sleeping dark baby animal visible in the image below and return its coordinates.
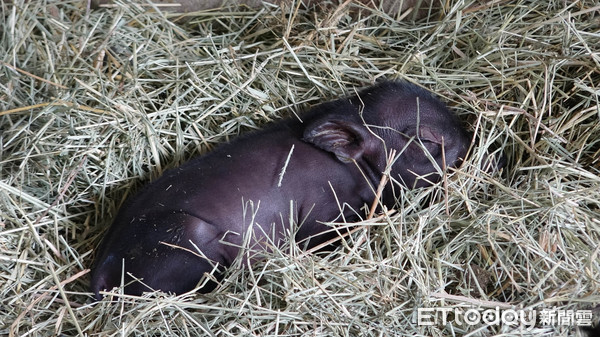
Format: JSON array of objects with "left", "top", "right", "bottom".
[{"left": 0, "top": 0, "right": 600, "bottom": 336}]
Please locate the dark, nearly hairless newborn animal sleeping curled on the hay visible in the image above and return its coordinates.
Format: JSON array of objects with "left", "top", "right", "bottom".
[{"left": 91, "top": 82, "right": 470, "bottom": 299}]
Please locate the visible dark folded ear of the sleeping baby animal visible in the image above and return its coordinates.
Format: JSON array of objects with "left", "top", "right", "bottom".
[{"left": 304, "top": 119, "right": 369, "bottom": 163}]
